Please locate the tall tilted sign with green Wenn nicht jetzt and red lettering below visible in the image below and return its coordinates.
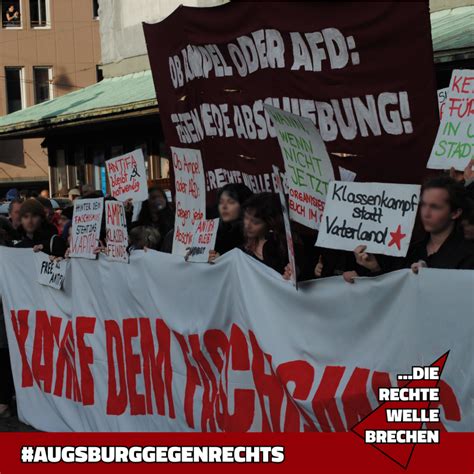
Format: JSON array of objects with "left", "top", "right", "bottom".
[{"left": 264, "top": 105, "right": 334, "bottom": 229}]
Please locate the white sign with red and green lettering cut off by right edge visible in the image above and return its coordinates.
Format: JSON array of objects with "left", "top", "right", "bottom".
[{"left": 427, "top": 69, "right": 474, "bottom": 171}]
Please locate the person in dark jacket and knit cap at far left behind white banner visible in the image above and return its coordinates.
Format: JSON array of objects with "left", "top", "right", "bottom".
[{"left": 15, "top": 198, "right": 67, "bottom": 257}]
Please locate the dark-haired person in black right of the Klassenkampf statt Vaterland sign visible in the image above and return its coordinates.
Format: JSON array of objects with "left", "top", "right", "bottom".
[{"left": 343, "top": 176, "right": 474, "bottom": 283}]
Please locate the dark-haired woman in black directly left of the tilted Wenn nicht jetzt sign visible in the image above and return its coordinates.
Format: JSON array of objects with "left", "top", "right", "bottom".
[{"left": 242, "top": 193, "right": 288, "bottom": 275}]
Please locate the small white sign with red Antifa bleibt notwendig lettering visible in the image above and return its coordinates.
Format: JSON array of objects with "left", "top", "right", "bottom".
[{"left": 105, "top": 148, "right": 148, "bottom": 202}]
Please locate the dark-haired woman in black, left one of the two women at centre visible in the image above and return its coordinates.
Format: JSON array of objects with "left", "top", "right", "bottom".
[{"left": 209, "top": 183, "right": 252, "bottom": 262}]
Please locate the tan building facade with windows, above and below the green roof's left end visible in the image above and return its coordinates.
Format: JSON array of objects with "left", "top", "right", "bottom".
[{"left": 0, "top": 0, "right": 100, "bottom": 196}]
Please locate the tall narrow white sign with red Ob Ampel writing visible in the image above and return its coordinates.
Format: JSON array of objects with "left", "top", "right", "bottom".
[{"left": 171, "top": 147, "right": 206, "bottom": 257}]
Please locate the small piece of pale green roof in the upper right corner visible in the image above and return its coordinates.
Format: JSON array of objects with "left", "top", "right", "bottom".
[{"left": 431, "top": 6, "right": 474, "bottom": 62}]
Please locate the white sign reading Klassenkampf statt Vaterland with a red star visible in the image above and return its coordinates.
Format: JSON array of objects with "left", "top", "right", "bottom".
[{"left": 316, "top": 181, "right": 420, "bottom": 257}]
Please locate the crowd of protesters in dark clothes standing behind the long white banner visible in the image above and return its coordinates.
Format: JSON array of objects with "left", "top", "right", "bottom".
[{"left": 0, "top": 162, "right": 474, "bottom": 417}]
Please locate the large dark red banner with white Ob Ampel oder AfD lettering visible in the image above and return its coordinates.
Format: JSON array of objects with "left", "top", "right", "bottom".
[{"left": 144, "top": 2, "right": 439, "bottom": 198}]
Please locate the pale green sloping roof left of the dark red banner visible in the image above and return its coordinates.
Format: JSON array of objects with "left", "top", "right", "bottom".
[{"left": 0, "top": 71, "right": 158, "bottom": 136}]
